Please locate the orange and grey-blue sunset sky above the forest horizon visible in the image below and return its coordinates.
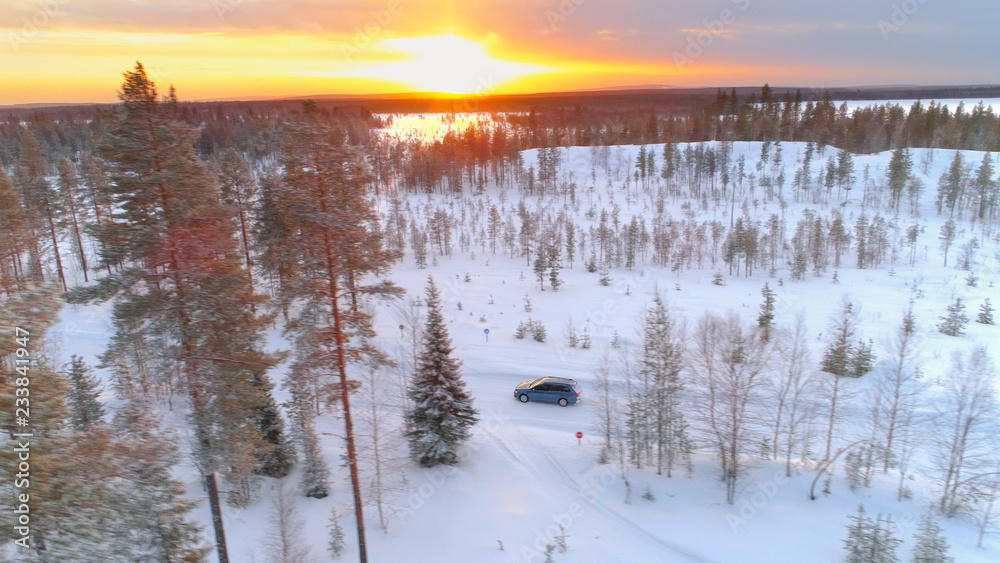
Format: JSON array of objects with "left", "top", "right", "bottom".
[{"left": 0, "top": 0, "right": 1000, "bottom": 105}]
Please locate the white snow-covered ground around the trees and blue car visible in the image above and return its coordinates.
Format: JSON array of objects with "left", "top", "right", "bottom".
[{"left": 54, "top": 138, "right": 1000, "bottom": 563}]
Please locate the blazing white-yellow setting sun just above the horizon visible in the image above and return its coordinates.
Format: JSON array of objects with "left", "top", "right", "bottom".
[{"left": 320, "top": 34, "right": 556, "bottom": 94}]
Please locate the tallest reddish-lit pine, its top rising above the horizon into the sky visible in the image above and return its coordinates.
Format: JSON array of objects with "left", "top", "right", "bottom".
[{"left": 70, "top": 64, "right": 284, "bottom": 556}]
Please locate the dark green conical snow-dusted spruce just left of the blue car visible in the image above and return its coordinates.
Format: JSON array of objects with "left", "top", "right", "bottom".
[{"left": 407, "top": 277, "right": 479, "bottom": 467}]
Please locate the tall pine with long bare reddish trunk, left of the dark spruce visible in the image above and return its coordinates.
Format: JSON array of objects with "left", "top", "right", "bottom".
[{"left": 274, "top": 102, "right": 402, "bottom": 561}]
